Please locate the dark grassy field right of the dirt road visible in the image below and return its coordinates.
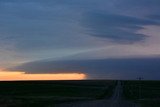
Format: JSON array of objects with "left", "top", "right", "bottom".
[{"left": 123, "top": 81, "right": 160, "bottom": 107}]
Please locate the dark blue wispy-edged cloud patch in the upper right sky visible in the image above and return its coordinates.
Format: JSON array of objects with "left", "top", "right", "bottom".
[{"left": 84, "top": 12, "right": 160, "bottom": 42}]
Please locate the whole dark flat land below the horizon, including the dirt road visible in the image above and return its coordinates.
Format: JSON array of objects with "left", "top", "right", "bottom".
[{"left": 0, "top": 80, "right": 160, "bottom": 107}]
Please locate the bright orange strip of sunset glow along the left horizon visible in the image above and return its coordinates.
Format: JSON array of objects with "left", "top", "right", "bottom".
[{"left": 0, "top": 70, "right": 86, "bottom": 81}]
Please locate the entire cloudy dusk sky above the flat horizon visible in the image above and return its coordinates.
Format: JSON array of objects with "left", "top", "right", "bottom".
[{"left": 0, "top": 0, "right": 160, "bottom": 80}]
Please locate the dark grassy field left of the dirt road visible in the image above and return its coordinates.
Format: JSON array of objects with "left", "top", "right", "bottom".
[{"left": 0, "top": 80, "right": 116, "bottom": 107}]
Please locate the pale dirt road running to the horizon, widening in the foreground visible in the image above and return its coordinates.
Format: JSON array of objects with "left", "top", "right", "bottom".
[{"left": 56, "top": 81, "right": 138, "bottom": 107}]
